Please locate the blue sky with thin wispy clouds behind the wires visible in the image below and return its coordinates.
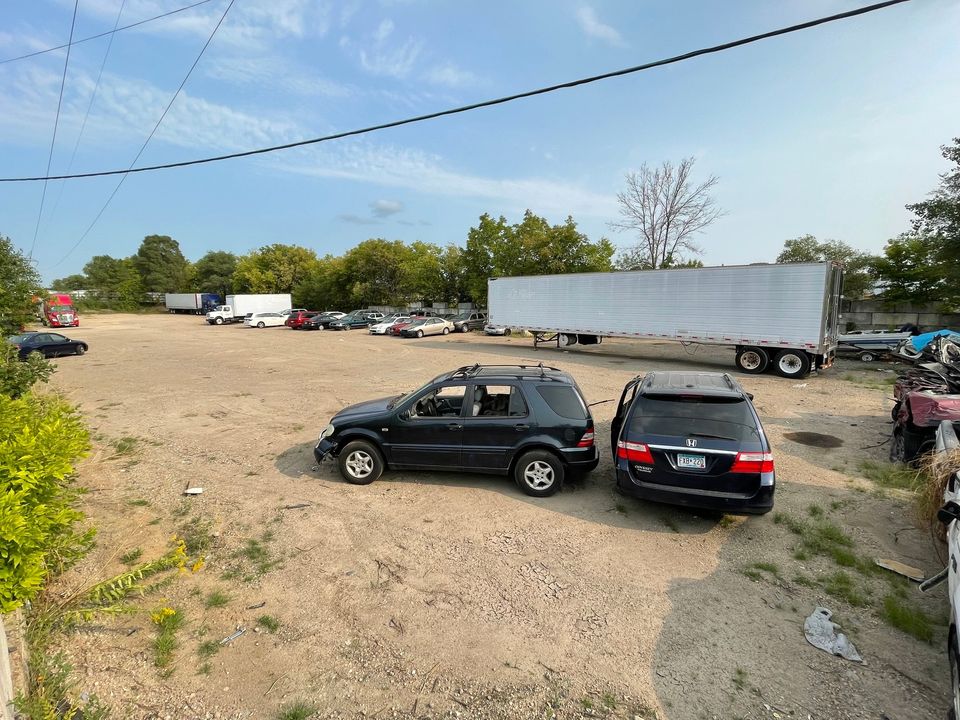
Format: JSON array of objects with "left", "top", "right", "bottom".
[{"left": 0, "top": 0, "right": 960, "bottom": 280}]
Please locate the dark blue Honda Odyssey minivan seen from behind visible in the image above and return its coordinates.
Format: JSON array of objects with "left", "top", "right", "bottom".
[{"left": 610, "top": 372, "right": 775, "bottom": 514}]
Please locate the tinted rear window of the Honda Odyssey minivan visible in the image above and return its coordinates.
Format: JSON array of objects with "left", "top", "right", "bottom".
[{"left": 630, "top": 395, "right": 758, "bottom": 440}]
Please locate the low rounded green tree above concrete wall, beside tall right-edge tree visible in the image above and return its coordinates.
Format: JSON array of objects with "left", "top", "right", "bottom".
[{"left": 871, "top": 233, "right": 947, "bottom": 304}]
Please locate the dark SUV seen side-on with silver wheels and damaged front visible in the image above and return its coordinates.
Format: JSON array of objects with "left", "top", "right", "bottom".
[{"left": 313, "top": 364, "right": 599, "bottom": 497}]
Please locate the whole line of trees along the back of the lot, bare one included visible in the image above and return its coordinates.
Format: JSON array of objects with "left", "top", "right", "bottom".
[{"left": 35, "top": 138, "right": 960, "bottom": 309}]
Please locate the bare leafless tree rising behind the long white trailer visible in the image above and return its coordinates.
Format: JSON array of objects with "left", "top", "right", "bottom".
[{"left": 609, "top": 157, "right": 723, "bottom": 270}]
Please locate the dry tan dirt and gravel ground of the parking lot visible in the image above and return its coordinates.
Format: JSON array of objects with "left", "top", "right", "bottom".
[{"left": 35, "top": 315, "right": 949, "bottom": 720}]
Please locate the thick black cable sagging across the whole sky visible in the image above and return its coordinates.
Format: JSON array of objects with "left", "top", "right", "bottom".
[{"left": 0, "top": 0, "right": 910, "bottom": 188}]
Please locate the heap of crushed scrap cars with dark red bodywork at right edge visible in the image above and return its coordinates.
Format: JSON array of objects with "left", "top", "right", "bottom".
[{"left": 890, "top": 330, "right": 960, "bottom": 463}]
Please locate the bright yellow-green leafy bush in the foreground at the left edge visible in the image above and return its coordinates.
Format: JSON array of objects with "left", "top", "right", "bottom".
[{"left": 0, "top": 394, "right": 93, "bottom": 613}]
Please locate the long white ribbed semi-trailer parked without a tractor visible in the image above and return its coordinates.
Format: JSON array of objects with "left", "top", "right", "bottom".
[{"left": 487, "top": 263, "right": 843, "bottom": 378}]
